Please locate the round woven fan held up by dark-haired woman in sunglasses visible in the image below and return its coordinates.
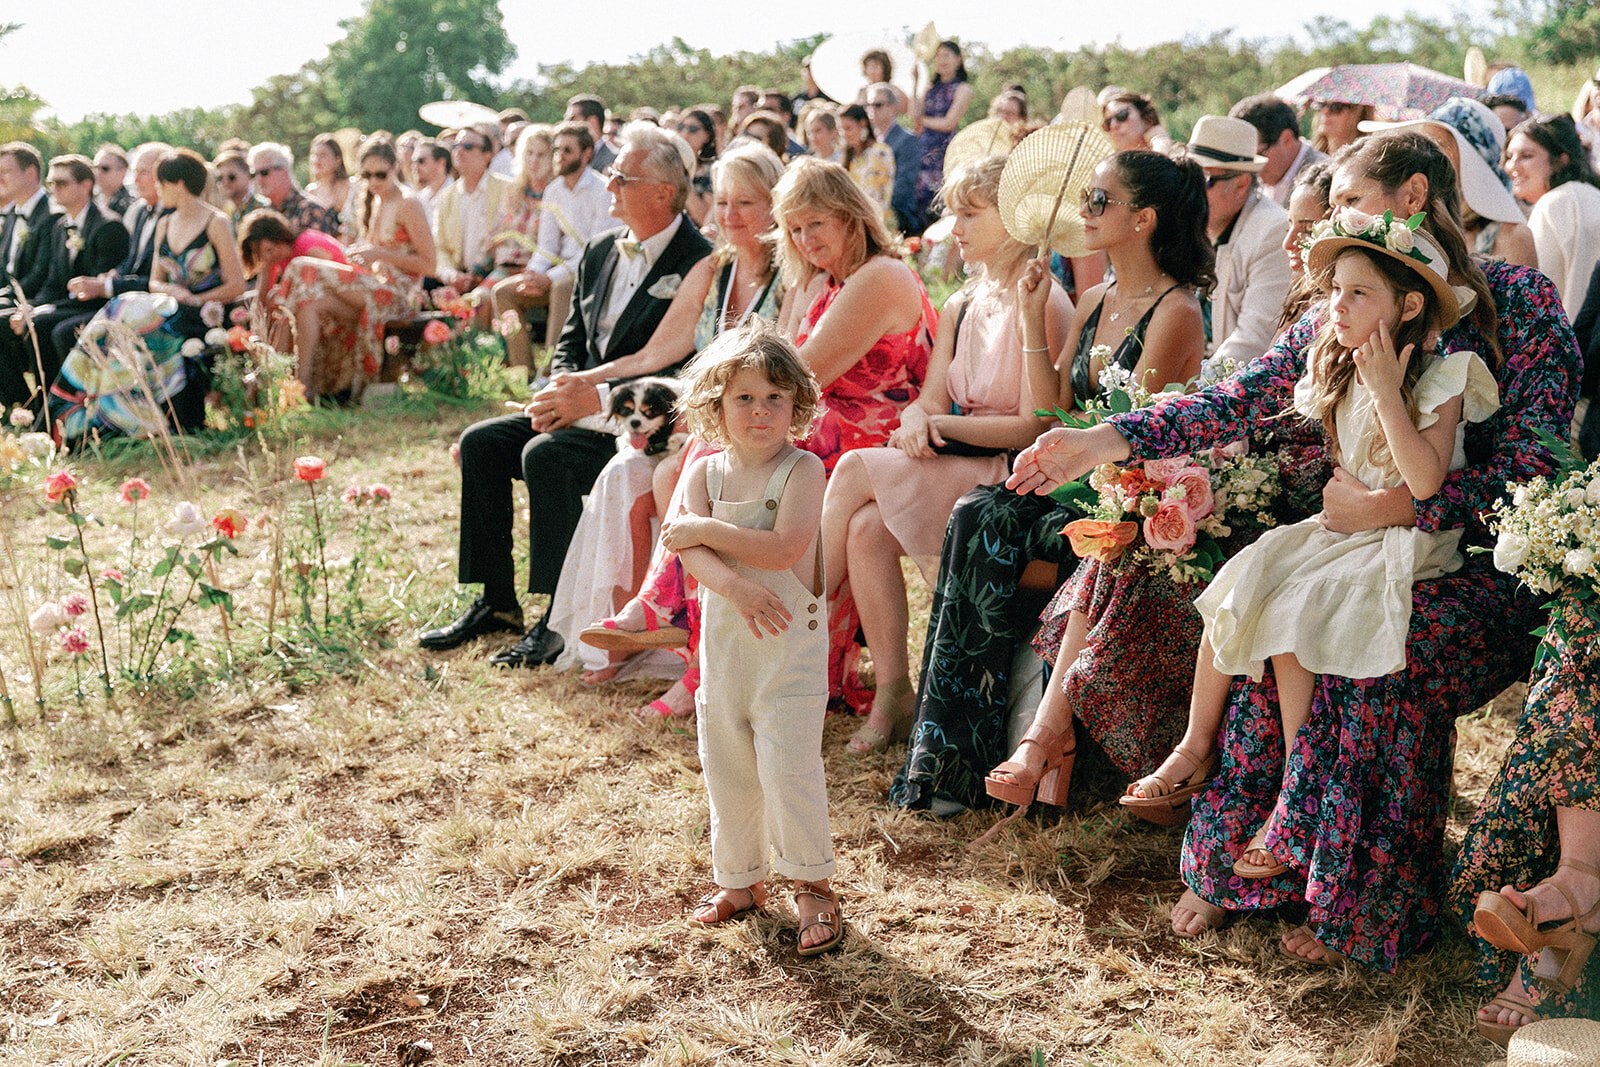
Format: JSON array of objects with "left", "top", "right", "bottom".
[{"left": 1000, "top": 122, "right": 1115, "bottom": 258}]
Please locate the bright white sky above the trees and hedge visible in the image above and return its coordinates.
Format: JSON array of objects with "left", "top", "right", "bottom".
[{"left": 0, "top": 0, "right": 1484, "bottom": 122}]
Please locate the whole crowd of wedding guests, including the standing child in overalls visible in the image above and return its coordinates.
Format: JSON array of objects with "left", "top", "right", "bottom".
[{"left": 9, "top": 42, "right": 1600, "bottom": 1043}]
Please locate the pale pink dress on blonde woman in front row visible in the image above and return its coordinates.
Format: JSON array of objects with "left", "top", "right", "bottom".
[{"left": 861, "top": 286, "right": 1022, "bottom": 585}]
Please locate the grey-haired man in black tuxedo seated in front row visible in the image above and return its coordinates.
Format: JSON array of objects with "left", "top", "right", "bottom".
[{"left": 419, "top": 123, "right": 710, "bottom": 667}]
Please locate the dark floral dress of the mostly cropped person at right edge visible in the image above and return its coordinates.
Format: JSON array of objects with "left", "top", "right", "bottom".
[{"left": 1450, "top": 597, "right": 1600, "bottom": 1017}]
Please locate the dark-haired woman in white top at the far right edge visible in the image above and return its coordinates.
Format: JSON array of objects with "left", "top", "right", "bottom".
[{"left": 1506, "top": 115, "right": 1600, "bottom": 320}]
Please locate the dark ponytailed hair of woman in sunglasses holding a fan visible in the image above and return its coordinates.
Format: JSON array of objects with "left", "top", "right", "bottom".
[{"left": 1110, "top": 149, "right": 1216, "bottom": 290}]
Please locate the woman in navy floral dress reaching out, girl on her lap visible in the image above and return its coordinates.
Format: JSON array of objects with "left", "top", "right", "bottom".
[{"left": 1008, "top": 133, "right": 1578, "bottom": 972}]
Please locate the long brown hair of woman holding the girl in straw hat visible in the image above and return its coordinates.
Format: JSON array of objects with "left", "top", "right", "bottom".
[{"left": 1333, "top": 130, "right": 1501, "bottom": 370}]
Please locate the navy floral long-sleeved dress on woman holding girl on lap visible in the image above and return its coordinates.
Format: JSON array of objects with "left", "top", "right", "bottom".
[{"left": 1112, "top": 264, "right": 1579, "bottom": 971}]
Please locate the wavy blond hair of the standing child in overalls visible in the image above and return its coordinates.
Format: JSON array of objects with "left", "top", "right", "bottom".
[{"left": 678, "top": 315, "right": 822, "bottom": 445}]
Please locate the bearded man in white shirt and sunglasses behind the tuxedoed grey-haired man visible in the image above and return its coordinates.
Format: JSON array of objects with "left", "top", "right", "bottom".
[{"left": 493, "top": 122, "right": 611, "bottom": 366}]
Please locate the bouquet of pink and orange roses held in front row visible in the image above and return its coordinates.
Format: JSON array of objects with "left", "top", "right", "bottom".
[{"left": 1053, "top": 350, "right": 1280, "bottom": 584}]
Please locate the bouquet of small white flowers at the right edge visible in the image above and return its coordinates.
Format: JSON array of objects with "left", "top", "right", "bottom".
[{"left": 1488, "top": 453, "right": 1600, "bottom": 656}]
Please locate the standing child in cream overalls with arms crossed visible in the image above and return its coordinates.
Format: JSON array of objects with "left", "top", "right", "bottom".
[{"left": 661, "top": 318, "right": 843, "bottom": 955}]
